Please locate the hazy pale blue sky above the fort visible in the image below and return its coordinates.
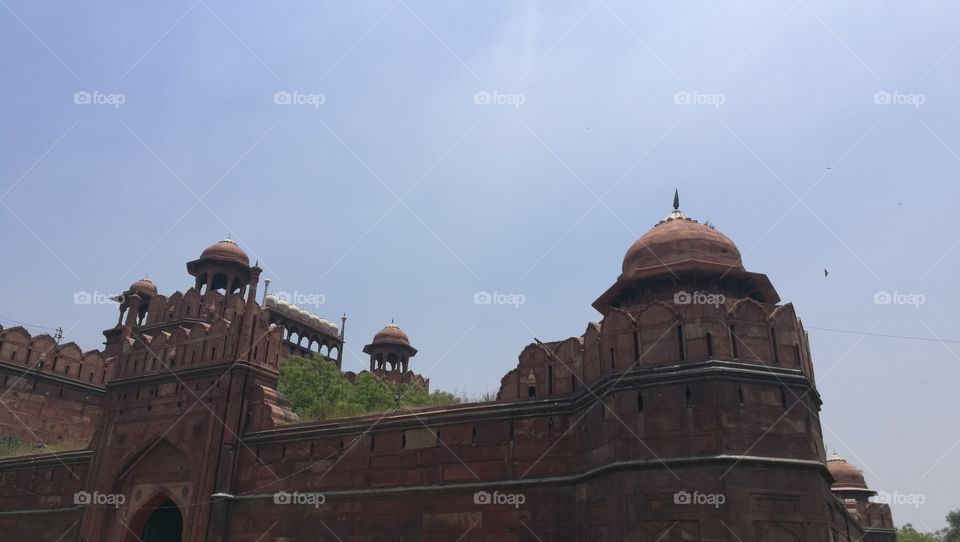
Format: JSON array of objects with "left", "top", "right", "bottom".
[{"left": 0, "top": 0, "right": 960, "bottom": 529}]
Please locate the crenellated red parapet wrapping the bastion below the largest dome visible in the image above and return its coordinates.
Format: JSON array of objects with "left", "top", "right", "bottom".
[{"left": 501, "top": 298, "right": 813, "bottom": 398}]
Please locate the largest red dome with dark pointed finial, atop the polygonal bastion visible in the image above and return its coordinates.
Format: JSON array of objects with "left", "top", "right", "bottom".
[{"left": 623, "top": 199, "right": 743, "bottom": 273}]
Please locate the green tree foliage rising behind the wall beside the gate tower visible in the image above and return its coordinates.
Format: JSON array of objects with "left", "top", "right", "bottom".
[{"left": 277, "top": 356, "right": 460, "bottom": 420}]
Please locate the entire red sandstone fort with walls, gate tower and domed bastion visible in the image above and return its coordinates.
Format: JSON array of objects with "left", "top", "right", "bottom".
[{"left": 0, "top": 198, "right": 895, "bottom": 542}]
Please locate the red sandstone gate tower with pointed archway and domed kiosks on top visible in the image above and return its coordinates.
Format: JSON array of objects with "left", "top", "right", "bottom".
[{"left": 80, "top": 240, "right": 282, "bottom": 542}]
